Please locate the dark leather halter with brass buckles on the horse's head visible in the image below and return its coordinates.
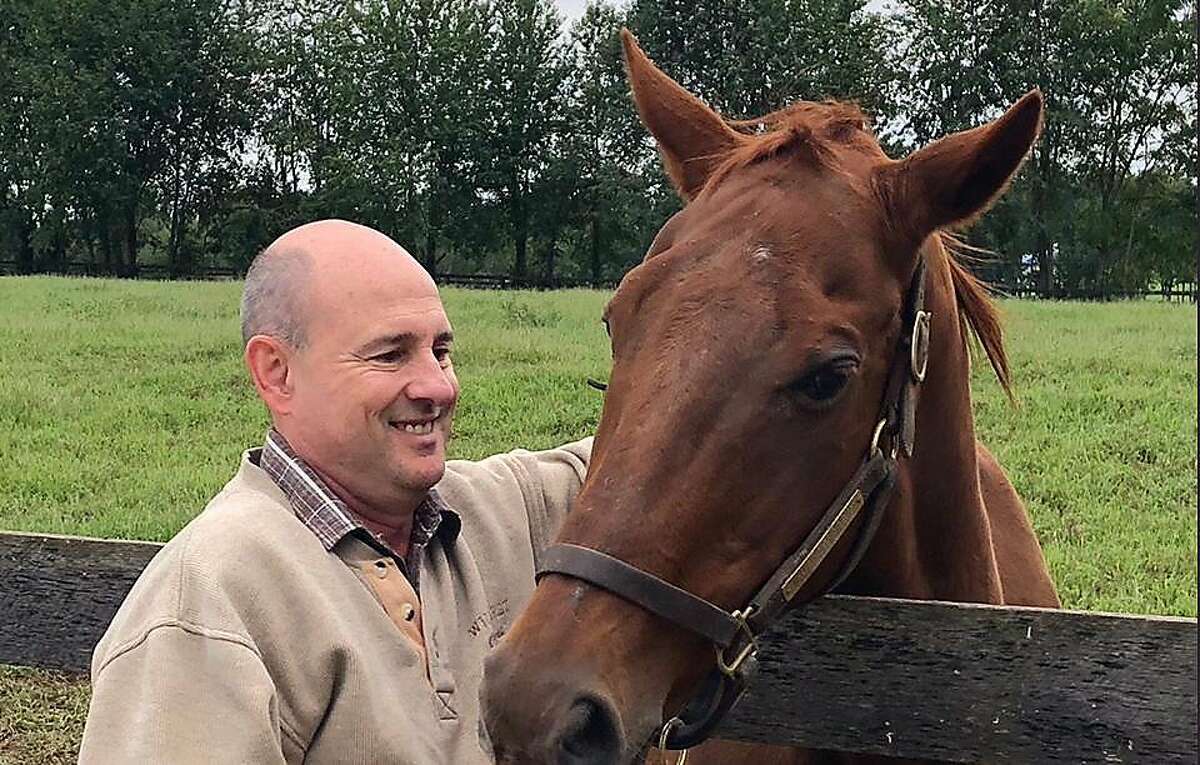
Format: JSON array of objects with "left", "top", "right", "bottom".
[{"left": 538, "top": 259, "right": 931, "bottom": 749}]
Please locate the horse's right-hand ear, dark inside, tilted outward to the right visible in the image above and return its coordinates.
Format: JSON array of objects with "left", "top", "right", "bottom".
[{"left": 882, "top": 90, "right": 1042, "bottom": 241}]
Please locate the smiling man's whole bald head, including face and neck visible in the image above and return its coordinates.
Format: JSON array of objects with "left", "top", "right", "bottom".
[{"left": 241, "top": 221, "right": 458, "bottom": 522}]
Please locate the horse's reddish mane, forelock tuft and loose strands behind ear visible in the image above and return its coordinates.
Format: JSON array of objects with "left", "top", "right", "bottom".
[{"left": 700, "top": 101, "right": 1015, "bottom": 402}]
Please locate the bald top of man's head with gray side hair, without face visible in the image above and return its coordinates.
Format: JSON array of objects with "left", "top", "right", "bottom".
[{"left": 241, "top": 219, "right": 437, "bottom": 348}]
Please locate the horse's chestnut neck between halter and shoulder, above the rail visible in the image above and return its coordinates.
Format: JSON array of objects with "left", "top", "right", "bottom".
[{"left": 845, "top": 249, "right": 1001, "bottom": 603}]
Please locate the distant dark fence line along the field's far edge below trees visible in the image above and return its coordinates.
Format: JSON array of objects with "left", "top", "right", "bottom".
[{"left": 0, "top": 260, "right": 1200, "bottom": 303}]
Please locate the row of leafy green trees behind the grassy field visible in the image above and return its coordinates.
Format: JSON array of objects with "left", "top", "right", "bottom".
[{"left": 0, "top": 0, "right": 1198, "bottom": 295}]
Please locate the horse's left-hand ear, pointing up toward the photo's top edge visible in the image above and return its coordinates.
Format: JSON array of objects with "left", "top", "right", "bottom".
[{"left": 620, "top": 29, "right": 738, "bottom": 201}]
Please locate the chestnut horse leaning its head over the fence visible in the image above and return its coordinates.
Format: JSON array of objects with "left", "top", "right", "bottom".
[{"left": 482, "top": 31, "right": 1058, "bottom": 765}]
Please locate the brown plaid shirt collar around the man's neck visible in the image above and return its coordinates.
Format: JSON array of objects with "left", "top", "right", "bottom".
[{"left": 258, "top": 428, "right": 462, "bottom": 572}]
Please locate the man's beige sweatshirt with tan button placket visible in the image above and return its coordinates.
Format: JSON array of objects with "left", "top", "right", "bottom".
[{"left": 79, "top": 439, "right": 592, "bottom": 764}]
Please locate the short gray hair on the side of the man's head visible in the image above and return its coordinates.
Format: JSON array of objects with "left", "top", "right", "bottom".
[{"left": 240, "top": 247, "right": 312, "bottom": 348}]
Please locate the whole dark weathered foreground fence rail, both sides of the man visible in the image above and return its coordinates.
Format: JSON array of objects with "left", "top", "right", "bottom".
[{"left": 0, "top": 532, "right": 1198, "bottom": 764}]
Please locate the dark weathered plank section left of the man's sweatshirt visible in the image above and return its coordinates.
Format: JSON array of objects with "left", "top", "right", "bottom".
[{"left": 0, "top": 532, "right": 162, "bottom": 671}]
